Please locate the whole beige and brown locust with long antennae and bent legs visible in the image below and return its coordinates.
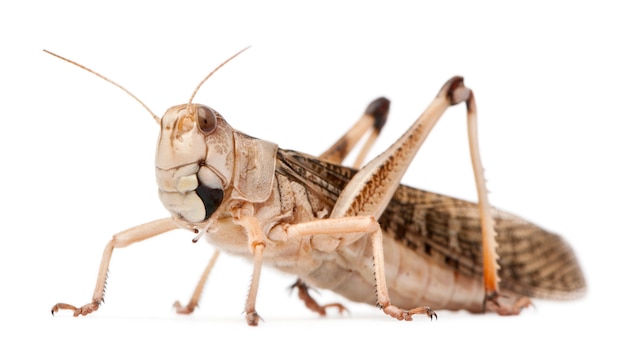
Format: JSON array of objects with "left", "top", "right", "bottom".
[{"left": 46, "top": 49, "right": 586, "bottom": 326}]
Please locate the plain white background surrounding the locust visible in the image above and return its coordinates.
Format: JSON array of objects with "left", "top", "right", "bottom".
[{"left": 0, "top": 1, "right": 626, "bottom": 337}]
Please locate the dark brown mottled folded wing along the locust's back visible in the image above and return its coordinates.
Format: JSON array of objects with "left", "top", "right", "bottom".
[{"left": 277, "top": 149, "right": 585, "bottom": 299}]
